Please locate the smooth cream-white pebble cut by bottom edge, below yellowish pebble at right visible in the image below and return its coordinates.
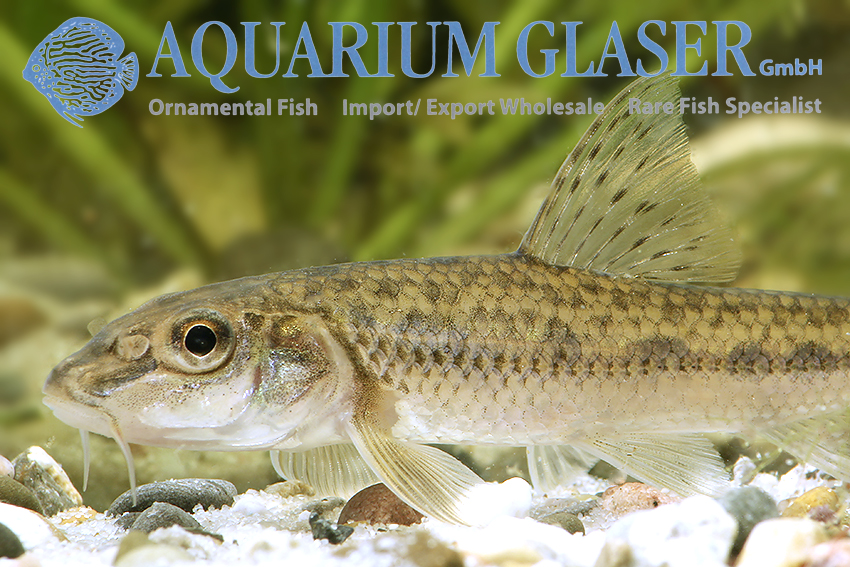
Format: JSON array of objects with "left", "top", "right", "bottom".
[{"left": 736, "top": 518, "right": 829, "bottom": 567}]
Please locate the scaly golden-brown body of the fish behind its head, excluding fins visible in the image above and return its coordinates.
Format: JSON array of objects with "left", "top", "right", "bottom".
[{"left": 272, "top": 255, "right": 850, "bottom": 445}]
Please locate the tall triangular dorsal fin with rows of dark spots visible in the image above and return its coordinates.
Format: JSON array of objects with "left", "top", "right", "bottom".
[{"left": 519, "top": 75, "right": 741, "bottom": 282}]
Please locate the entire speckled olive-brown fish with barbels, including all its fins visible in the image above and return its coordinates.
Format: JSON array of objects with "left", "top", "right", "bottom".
[{"left": 44, "top": 76, "right": 850, "bottom": 523}]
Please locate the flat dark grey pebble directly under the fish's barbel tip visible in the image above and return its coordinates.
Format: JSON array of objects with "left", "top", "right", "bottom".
[{"left": 106, "top": 478, "right": 236, "bottom": 516}]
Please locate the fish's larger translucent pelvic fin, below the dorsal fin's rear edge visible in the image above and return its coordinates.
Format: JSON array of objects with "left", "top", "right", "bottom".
[{"left": 577, "top": 433, "right": 729, "bottom": 496}]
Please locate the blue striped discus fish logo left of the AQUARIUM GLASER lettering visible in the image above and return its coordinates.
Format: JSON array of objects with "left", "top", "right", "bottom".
[{"left": 24, "top": 18, "right": 139, "bottom": 128}]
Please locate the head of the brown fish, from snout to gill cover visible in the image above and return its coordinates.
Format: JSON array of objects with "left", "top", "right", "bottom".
[{"left": 43, "top": 278, "right": 350, "bottom": 450}]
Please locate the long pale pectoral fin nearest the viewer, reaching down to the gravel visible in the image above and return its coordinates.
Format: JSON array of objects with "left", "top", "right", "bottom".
[{"left": 347, "top": 420, "right": 476, "bottom": 524}]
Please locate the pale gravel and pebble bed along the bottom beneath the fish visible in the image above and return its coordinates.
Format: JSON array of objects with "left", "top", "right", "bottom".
[{"left": 0, "top": 466, "right": 850, "bottom": 567}]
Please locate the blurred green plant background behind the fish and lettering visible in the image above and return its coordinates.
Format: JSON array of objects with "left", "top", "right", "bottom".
[{"left": 0, "top": 0, "right": 850, "bottom": 508}]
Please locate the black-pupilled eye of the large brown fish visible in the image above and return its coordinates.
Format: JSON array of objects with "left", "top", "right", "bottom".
[{"left": 162, "top": 308, "right": 236, "bottom": 374}]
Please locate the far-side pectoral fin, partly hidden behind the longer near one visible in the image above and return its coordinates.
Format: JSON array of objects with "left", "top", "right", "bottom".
[{"left": 271, "top": 443, "right": 380, "bottom": 498}]
